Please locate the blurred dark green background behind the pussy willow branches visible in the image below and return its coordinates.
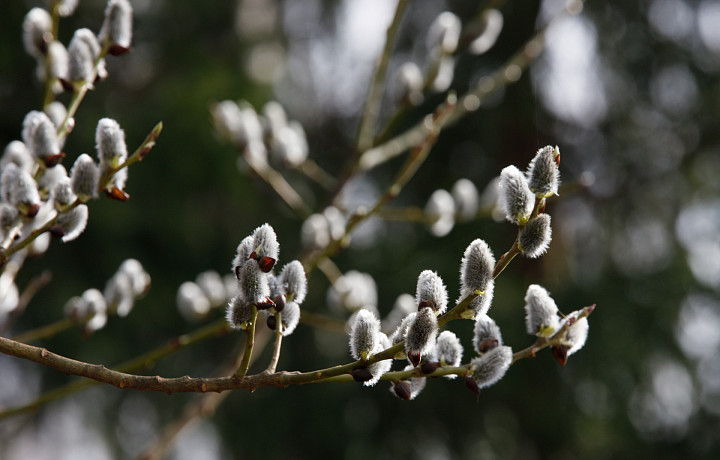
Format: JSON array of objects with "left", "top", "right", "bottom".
[{"left": 0, "top": 0, "right": 720, "bottom": 459}]
